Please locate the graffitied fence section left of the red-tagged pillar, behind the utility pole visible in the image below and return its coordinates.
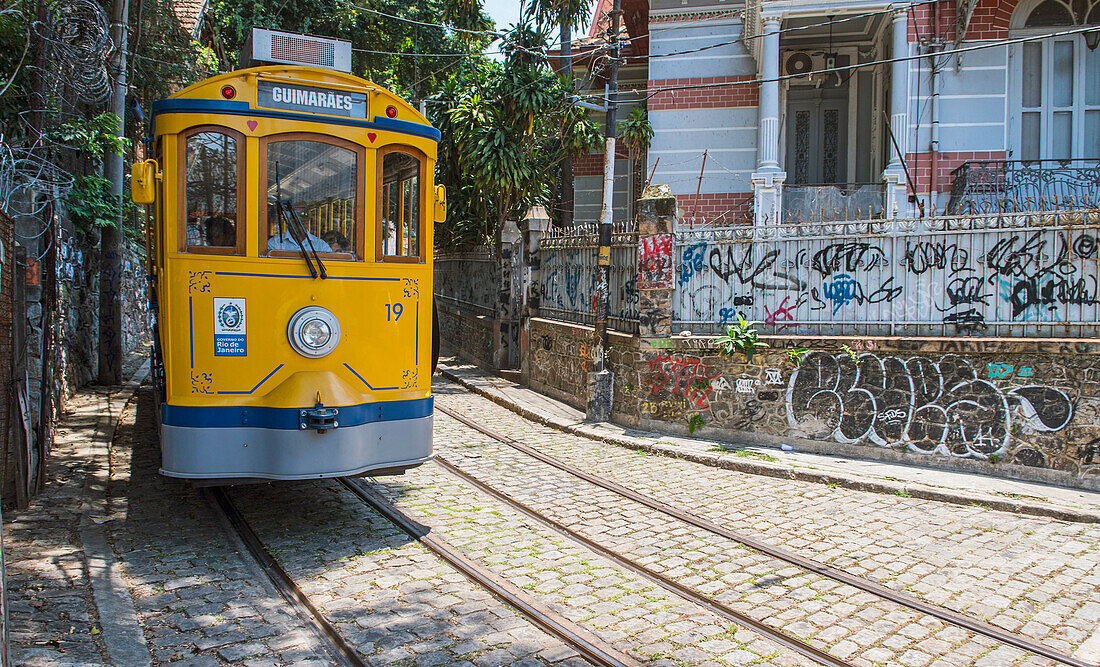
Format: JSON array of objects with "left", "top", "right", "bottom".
[{"left": 539, "top": 222, "right": 638, "bottom": 334}]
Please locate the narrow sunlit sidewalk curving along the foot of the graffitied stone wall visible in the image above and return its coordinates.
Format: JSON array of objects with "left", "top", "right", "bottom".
[{"left": 439, "top": 358, "right": 1100, "bottom": 523}]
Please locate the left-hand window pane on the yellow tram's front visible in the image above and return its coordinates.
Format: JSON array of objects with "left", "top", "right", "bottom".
[{"left": 184, "top": 131, "right": 239, "bottom": 252}]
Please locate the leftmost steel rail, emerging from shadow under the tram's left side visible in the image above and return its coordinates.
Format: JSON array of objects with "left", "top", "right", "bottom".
[{"left": 206, "top": 486, "right": 366, "bottom": 667}]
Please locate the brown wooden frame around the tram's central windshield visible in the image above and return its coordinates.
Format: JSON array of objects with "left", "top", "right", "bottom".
[{"left": 256, "top": 132, "right": 366, "bottom": 262}]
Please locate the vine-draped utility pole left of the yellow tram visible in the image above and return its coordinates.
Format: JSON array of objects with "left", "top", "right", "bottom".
[{"left": 99, "top": 0, "right": 130, "bottom": 384}]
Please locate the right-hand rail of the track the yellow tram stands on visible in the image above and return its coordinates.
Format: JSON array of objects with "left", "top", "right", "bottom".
[{"left": 340, "top": 478, "right": 640, "bottom": 667}]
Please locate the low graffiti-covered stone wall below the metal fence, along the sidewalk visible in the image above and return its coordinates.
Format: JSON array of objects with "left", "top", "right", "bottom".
[{"left": 524, "top": 310, "right": 1100, "bottom": 490}]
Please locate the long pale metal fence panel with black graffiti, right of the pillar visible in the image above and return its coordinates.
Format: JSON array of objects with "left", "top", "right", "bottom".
[{"left": 673, "top": 210, "right": 1100, "bottom": 337}]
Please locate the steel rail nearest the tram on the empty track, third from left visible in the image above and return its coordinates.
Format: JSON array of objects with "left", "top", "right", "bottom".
[{"left": 436, "top": 456, "right": 853, "bottom": 667}]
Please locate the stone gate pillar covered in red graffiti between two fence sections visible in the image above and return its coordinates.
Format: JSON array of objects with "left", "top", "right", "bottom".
[{"left": 637, "top": 185, "right": 677, "bottom": 340}]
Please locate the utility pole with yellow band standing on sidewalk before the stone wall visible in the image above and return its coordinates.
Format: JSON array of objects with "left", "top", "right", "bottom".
[{"left": 587, "top": 0, "right": 623, "bottom": 422}]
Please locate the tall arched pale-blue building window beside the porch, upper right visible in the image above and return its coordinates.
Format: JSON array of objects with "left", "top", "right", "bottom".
[{"left": 1016, "top": 0, "right": 1100, "bottom": 161}]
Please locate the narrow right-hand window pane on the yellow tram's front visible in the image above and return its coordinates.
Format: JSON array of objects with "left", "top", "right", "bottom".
[{"left": 378, "top": 151, "right": 422, "bottom": 260}]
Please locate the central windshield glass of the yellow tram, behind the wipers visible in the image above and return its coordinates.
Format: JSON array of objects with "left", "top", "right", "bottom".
[{"left": 266, "top": 140, "right": 359, "bottom": 259}]
